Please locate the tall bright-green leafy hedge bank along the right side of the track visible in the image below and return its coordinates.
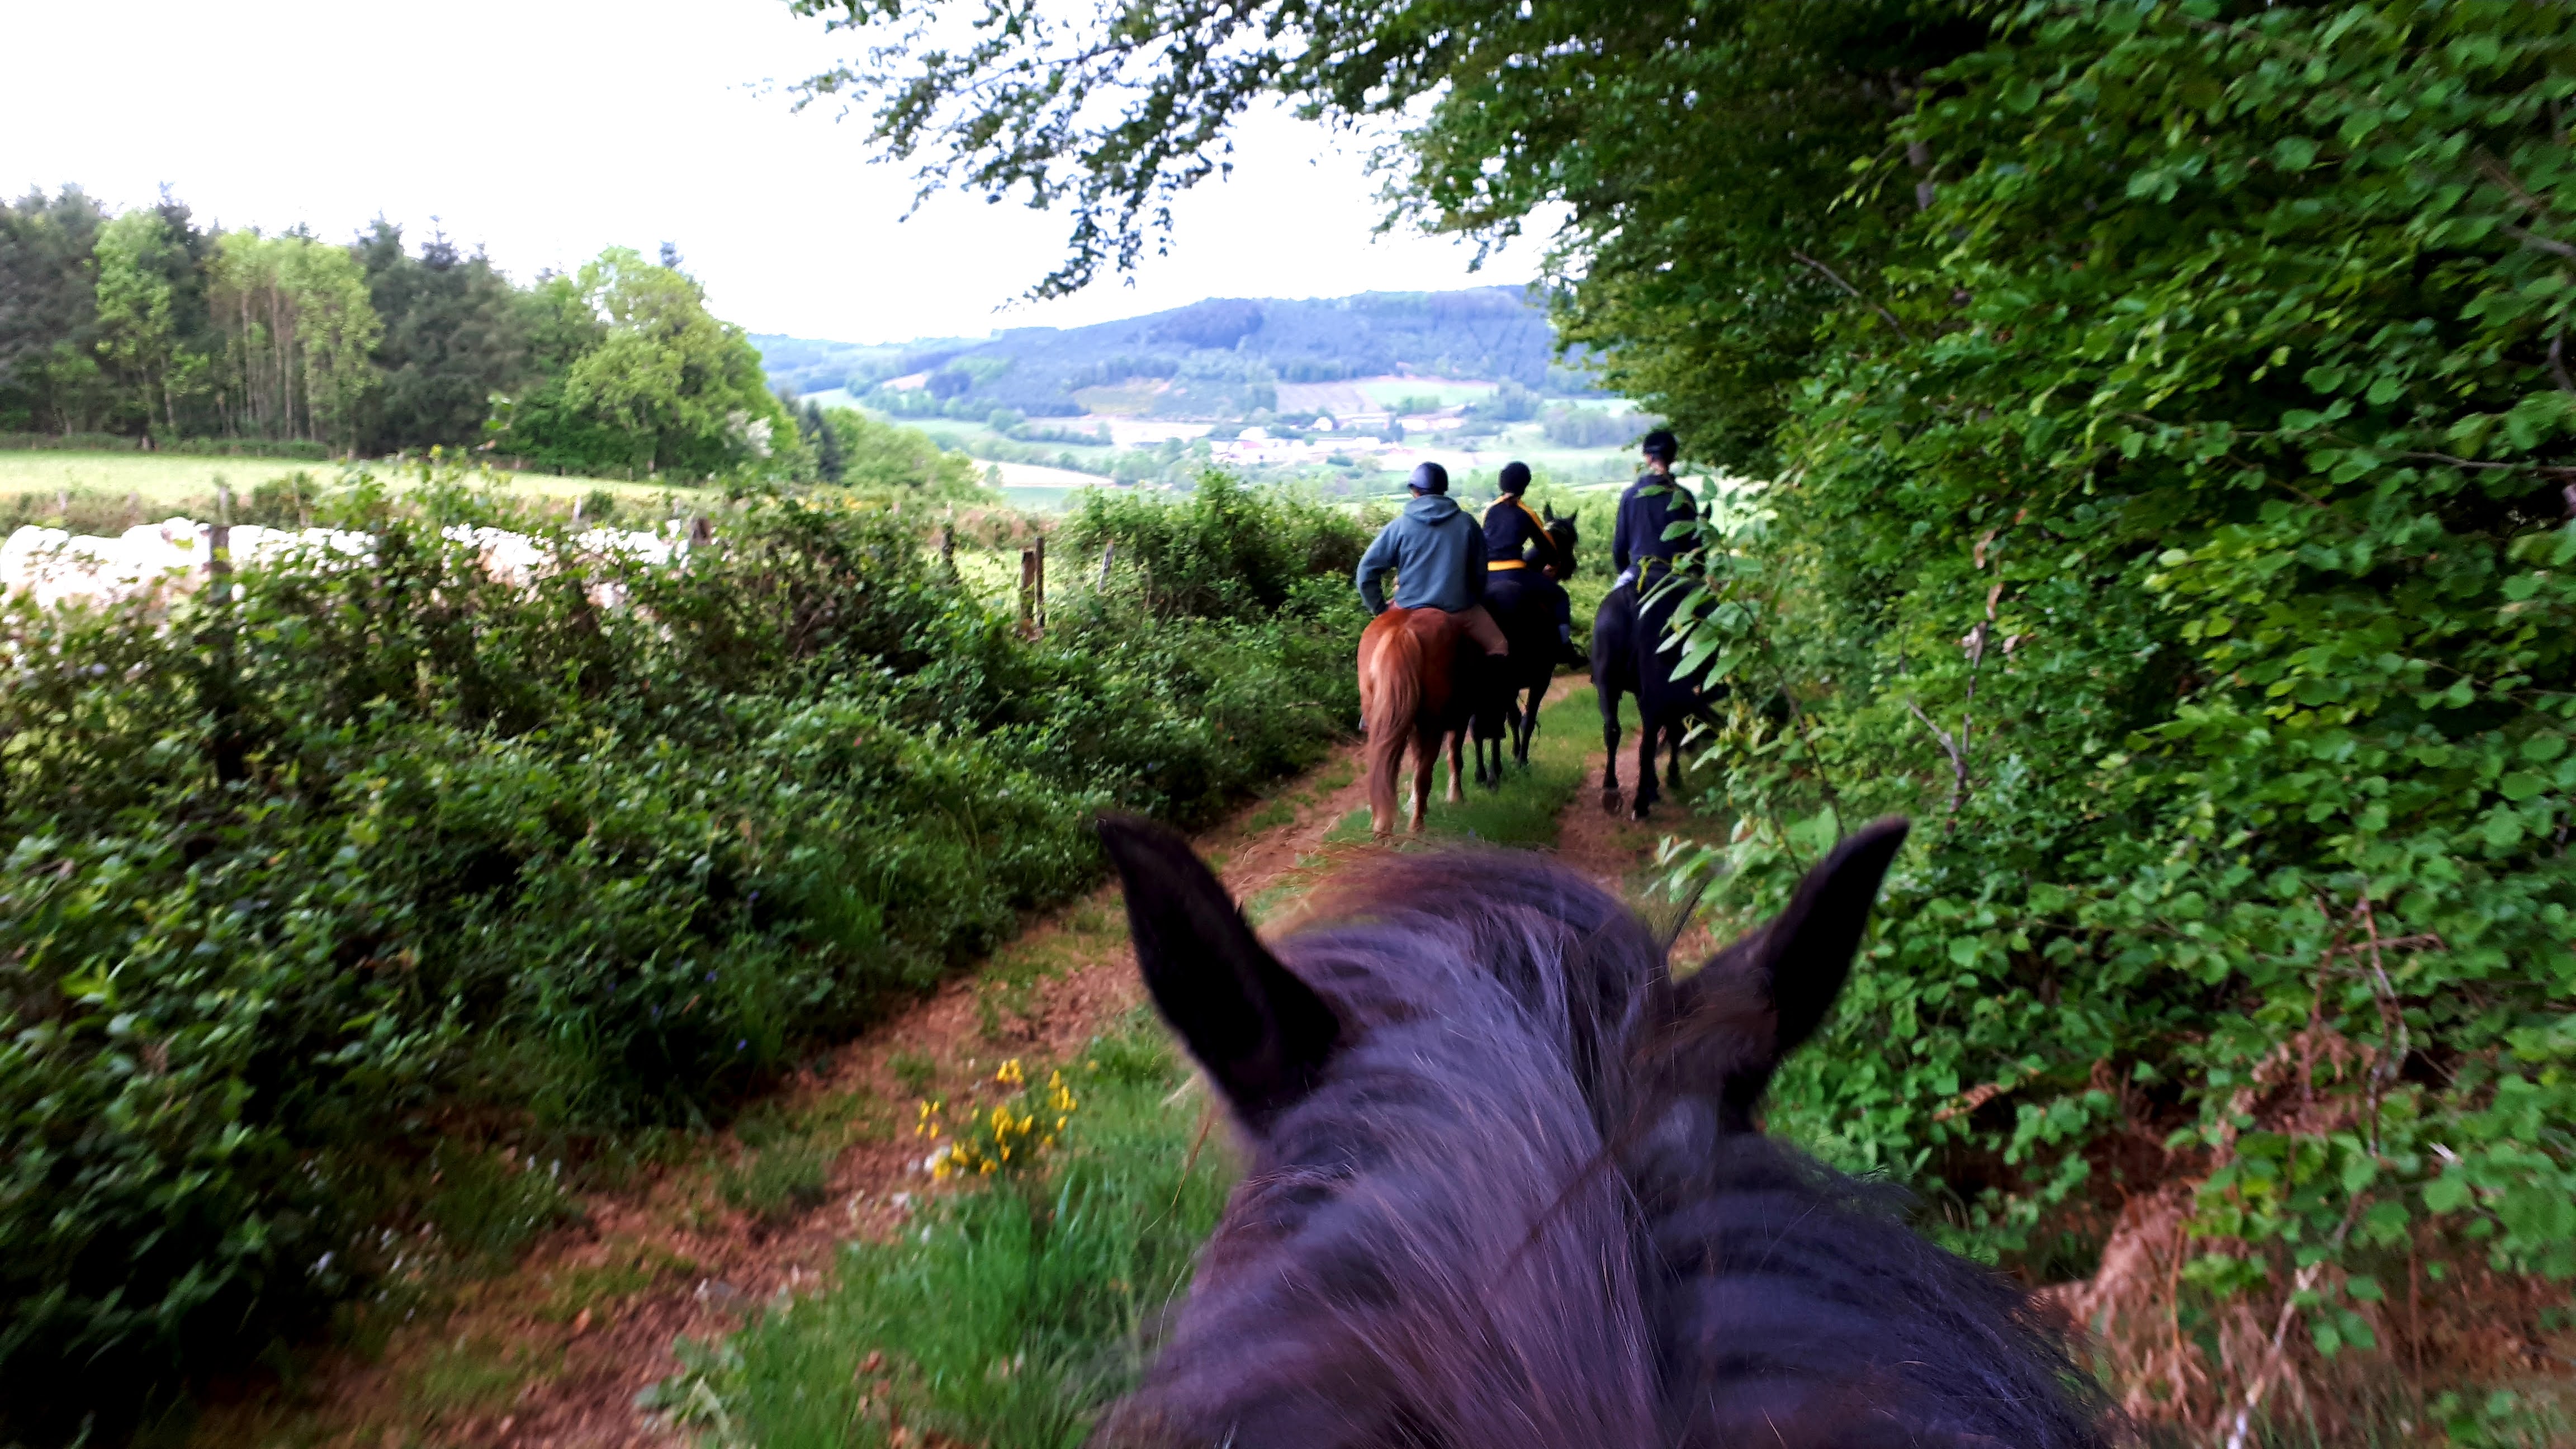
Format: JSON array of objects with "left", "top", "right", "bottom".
[{"left": 1687, "top": 0, "right": 2576, "bottom": 1426}]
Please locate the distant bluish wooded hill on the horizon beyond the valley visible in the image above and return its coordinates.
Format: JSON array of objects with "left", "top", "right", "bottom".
[{"left": 752, "top": 286, "right": 1592, "bottom": 420}]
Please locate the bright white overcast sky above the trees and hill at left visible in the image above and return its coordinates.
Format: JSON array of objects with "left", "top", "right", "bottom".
[{"left": 0, "top": 0, "right": 1533, "bottom": 343}]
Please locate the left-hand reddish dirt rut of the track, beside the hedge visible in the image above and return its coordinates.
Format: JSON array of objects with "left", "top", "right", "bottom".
[{"left": 196, "top": 748, "right": 1365, "bottom": 1449}]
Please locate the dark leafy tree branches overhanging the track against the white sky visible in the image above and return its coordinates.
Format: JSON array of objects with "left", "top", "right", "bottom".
[{"left": 791, "top": 0, "right": 1983, "bottom": 459}]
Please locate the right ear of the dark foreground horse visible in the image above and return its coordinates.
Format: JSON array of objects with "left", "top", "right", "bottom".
[{"left": 1682, "top": 815, "right": 1911, "bottom": 1109}]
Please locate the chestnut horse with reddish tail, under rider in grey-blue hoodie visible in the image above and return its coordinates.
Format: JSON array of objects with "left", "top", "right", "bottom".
[{"left": 1360, "top": 608, "right": 1484, "bottom": 838}]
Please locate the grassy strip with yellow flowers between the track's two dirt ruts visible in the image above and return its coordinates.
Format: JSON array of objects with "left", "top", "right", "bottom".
[{"left": 649, "top": 686, "right": 1597, "bottom": 1449}]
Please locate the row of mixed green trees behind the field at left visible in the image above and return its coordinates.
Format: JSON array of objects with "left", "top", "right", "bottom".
[{"left": 0, "top": 188, "right": 812, "bottom": 482}]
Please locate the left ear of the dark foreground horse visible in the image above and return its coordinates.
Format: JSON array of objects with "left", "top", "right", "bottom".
[{"left": 1097, "top": 815, "right": 1342, "bottom": 1132}]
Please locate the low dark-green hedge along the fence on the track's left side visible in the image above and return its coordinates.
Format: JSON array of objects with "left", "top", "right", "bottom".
[{"left": 0, "top": 458, "right": 1357, "bottom": 1436}]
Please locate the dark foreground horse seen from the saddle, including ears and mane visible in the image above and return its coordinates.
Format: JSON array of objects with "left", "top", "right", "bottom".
[{"left": 1092, "top": 820, "right": 2107, "bottom": 1449}]
